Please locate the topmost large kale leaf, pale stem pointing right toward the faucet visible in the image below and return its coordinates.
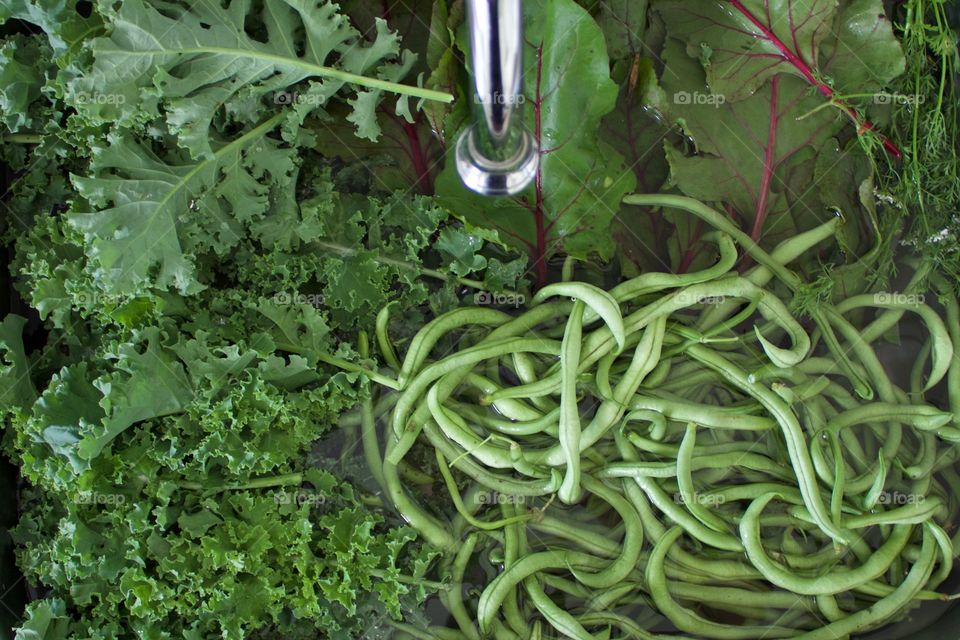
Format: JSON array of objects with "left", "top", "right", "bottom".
[{"left": 68, "top": 0, "right": 415, "bottom": 158}]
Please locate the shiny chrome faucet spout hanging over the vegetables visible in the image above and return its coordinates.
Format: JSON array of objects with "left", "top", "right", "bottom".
[{"left": 456, "top": 0, "right": 540, "bottom": 195}]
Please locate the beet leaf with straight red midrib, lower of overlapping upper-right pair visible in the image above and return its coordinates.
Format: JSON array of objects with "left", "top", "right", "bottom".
[{"left": 662, "top": 39, "right": 843, "bottom": 242}]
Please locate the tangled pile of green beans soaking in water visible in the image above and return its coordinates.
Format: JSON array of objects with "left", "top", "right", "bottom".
[{"left": 361, "top": 195, "right": 960, "bottom": 640}]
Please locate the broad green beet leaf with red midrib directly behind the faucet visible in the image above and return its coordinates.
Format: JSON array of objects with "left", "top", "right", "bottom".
[{"left": 437, "top": 0, "right": 635, "bottom": 283}]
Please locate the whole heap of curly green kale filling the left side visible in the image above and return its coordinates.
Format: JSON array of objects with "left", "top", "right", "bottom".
[{"left": 0, "top": 1, "right": 525, "bottom": 639}]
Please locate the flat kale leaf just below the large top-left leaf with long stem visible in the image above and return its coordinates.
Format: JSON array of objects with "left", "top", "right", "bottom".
[{"left": 70, "top": 116, "right": 295, "bottom": 294}]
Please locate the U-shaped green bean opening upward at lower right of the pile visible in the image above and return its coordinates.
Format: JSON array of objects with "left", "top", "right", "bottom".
[{"left": 740, "top": 493, "right": 913, "bottom": 596}]
